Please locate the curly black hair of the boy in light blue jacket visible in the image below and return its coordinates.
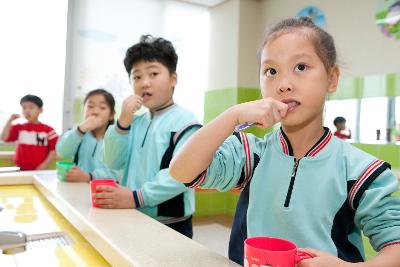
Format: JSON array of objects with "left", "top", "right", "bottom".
[{"left": 124, "top": 35, "right": 178, "bottom": 76}]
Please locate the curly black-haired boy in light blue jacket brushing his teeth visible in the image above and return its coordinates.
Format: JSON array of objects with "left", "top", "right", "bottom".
[{"left": 95, "top": 35, "right": 200, "bottom": 238}]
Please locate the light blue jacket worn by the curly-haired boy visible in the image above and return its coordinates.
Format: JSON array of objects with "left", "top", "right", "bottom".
[{"left": 104, "top": 105, "right": 200, "bottom": 224}]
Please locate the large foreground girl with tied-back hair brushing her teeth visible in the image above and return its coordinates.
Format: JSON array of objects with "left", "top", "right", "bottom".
[{"left": 170, "top": 17, "right": 400, "bottom": 267}]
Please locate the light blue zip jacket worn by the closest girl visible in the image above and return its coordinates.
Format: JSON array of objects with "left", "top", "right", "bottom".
[{"left": 189, "top": 128, "right": 400, "bottom": 264}]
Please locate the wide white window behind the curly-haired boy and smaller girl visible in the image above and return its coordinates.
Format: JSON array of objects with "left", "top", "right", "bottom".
[{"left": 66, "top": 0, "right": 209, "bottom": 128}]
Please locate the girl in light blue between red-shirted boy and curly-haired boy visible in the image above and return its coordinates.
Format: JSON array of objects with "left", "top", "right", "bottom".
[{"left": 56, "top": 89, "right": 119, "bottom": 182}]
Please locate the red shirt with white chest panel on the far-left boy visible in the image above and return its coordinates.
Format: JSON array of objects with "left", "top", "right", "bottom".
[{"left": 6, "top": 122, "right": 58, "bottom": 170}]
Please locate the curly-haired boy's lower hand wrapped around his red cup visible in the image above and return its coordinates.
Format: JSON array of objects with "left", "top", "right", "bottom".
[{"left": 93, "top": 185, "right": 136, "bottom": 209}]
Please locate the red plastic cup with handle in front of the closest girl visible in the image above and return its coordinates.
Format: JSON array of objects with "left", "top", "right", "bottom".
[{"left": 244, "top": 236, "right": 312, "bottom": 267}]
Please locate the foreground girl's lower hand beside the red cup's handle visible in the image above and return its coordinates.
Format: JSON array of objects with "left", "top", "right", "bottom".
[{"left": 297, "top": 248, "right": 353, "bottom": 267}]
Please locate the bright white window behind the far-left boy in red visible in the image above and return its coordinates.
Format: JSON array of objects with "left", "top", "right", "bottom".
[{"left": 0, "top": 0, "right": 68, "bottom": 133}]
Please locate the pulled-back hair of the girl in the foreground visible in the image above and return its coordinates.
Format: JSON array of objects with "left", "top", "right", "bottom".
[{"left": 259, "top": 17, "right": 336, "bottom": 71}]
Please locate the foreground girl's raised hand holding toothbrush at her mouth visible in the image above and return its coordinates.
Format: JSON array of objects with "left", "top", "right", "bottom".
[{"left": 236, "top": 98, "right": 288, "bottom": 128}]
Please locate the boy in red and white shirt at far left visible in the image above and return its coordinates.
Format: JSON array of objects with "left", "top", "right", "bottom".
[{"left": 1, "top": 94, "right": 58, "bottom": 170}]
